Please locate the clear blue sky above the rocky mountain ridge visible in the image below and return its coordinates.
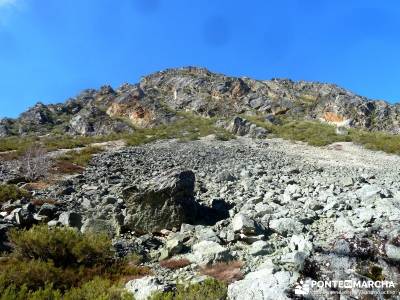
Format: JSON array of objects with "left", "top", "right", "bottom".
[{"left": 0, "top": 0, "right": 400, "bottom": 117}]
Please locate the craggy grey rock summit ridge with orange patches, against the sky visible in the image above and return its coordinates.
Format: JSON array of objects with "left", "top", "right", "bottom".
[{"left": 0, "top": 67, "right": 400, "bottom": 136}]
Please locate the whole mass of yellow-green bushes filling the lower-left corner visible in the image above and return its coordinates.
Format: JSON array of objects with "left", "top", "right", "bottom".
[{"left": 0, "top": 225, "right": 150, "bottom": 299}]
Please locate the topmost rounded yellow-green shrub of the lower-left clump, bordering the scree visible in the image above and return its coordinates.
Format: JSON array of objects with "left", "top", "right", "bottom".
[{"left": 9, "top": 225, "right": 114, "bottom": 267}]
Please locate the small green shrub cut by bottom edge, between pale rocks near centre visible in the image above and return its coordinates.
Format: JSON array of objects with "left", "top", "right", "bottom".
[{"left": 151, "top": 279, "right": 227, "bottom": 300}]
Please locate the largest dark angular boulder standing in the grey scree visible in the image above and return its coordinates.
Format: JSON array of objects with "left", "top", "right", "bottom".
[{"left": 123, "top": 169, "right": 198, "bottom": 232}]
